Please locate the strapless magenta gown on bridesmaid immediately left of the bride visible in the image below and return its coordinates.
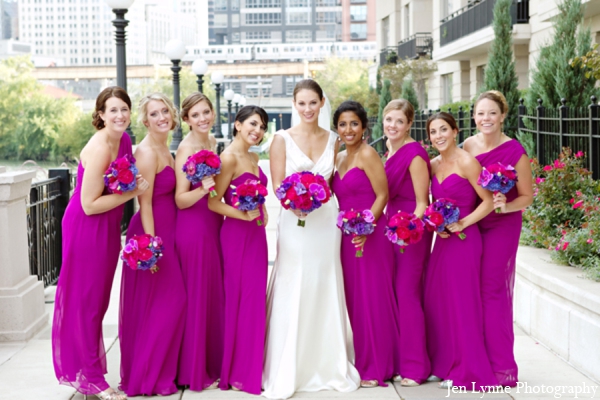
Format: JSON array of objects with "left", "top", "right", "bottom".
[{"left": 219, "top": 168, "right": 269, "bottom": 395}]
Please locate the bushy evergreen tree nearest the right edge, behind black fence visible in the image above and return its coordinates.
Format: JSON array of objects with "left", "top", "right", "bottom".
[{"left": 527, "top": 0, "right": 595, "bottom": 109}]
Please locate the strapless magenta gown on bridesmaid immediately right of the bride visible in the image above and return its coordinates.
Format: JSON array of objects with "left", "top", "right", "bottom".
[{"left": 332, "top": 167, "right": 400, "bottom": 386}]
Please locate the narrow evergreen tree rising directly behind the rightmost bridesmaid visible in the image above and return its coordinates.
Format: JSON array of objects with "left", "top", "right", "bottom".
[{"left": 482, "top": 0, "right": 519, "bottom": 137}]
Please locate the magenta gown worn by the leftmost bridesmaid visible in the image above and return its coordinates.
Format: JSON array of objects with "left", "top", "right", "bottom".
[{"left": 52, "top": 133, "right": 131, "bottom": 395}]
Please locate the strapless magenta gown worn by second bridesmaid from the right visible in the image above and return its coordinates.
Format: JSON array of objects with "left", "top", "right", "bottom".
[{"left": 424, "top": 174, "right": 498, "bottom": 390}]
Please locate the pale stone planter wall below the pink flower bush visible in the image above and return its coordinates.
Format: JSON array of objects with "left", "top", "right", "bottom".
[{"left": 514, "top": 246, "right": 600, "bottom": 382}]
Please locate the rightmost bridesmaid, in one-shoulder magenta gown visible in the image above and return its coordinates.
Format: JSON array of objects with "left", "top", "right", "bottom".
[{"left": 463, "top": 91, "right": 533, "bottom": 386}]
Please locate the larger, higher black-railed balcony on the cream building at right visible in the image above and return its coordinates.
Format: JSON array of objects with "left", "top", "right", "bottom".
[{"left": 440, "top": 0, "right": 529, "bottom": 46}]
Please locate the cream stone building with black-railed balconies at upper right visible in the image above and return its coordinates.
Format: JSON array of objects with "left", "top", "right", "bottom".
[{"left": 376, "top": 0, "right": 600, "bottom": 109}]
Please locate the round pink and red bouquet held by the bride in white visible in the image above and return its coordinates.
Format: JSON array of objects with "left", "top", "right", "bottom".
[{"left": 275, "top": 171, "right": 331, "bottom": 227}]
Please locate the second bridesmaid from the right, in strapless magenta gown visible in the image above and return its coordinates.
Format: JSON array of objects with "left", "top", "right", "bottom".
[{"left": 424, "top": 112, "right": 498, "bottom": 390}]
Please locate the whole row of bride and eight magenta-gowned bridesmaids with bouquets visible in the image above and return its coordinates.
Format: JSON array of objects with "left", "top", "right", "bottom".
[{"left": 52, "top": 79, "right": 533, "bottom": 400}]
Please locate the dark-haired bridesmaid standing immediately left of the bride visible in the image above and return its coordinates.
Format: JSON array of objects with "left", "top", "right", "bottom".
[{"left": 208, "top": 106, "right": 269, "bottom": 395}]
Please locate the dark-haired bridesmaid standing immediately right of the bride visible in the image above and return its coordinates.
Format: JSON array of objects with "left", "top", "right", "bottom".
[{"left": 332, "top": 101, "right": 400, "bottom": 388}]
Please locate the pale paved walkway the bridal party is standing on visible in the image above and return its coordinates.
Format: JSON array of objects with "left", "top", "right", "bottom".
[{"left": 0, "top": 161, "right": 600, "bottom": 400}]
